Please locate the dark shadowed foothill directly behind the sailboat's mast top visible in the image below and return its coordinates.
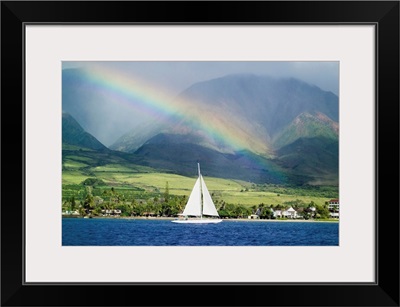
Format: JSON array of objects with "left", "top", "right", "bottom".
[{"left": 134, "top": 134, "right": 286, "bottom": 183}]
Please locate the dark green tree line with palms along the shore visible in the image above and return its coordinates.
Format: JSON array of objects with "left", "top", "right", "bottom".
[{"left": 62, "top": 182, "right": 329, "bottom": 219}]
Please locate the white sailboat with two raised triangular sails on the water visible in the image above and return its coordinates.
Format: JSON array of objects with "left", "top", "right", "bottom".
[{"left": 172, "top": 163, "right": 222, "bottom": 224}]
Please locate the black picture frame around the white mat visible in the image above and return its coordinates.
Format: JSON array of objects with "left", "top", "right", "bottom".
[{"left": 1, "top": 1, "right": 399, "bottom": 306}]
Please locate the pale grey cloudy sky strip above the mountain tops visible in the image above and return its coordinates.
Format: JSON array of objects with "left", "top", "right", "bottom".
[{"left": 63, "top": 61, "right": 339, "bottom": 95}]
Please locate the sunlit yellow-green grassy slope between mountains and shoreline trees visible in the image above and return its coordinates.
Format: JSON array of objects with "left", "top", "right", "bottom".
[{"left": 62, "top": 149, "right": 338, "bottom": 207}]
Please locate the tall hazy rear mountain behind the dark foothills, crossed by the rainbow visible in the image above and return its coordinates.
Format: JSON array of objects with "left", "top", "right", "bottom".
[{"left": 110, "top": 74, "right": 338, "bottom": 156}]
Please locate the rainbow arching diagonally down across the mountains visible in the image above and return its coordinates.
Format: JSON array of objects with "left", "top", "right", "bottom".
[{"left": 65, "top": 63, "right": 284, "bottom": 182}]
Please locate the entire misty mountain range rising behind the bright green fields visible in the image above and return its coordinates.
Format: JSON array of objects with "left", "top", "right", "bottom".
[{"left": 63, "top": 71, "right": 339, "bottom": 184}]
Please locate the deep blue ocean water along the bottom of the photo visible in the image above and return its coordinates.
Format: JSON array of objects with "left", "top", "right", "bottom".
[{"left": 62, "top": 218, "right": 339, "bottom": 246}]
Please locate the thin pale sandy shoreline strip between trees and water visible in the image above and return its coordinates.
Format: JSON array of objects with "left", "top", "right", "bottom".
[{"left": 62, "top": 215, "right": 339, "bottom": 223}]
